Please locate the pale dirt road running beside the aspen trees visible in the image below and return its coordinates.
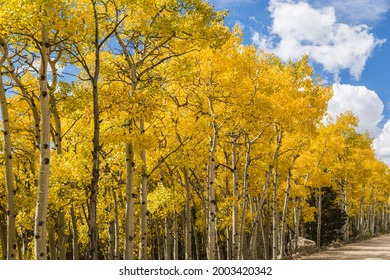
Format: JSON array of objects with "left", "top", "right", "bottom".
[{"left": 293, "top": 234, "right": 390, "bottom": 260}]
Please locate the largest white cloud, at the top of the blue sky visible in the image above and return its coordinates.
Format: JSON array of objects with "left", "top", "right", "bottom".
[{"left": 252, "top": 0, "right": 385, "bottom": 80}]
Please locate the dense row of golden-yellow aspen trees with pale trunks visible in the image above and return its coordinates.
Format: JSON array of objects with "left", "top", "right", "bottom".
[{"left": 0, "top": 0, "right": 390, "bottom": 259}]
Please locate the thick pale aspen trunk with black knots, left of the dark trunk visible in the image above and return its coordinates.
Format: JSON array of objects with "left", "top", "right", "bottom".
[{"left": 34, "top": 25, "right": 50, "bottom": 260}]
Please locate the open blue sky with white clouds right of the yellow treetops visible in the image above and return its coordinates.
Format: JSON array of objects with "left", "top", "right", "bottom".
[{"left": 208, "top": 0, "right": 390, "bottom": 166}]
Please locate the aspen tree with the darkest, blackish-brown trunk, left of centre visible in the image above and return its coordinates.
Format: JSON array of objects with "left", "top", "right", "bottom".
[{"left": 66, "top": 0, "right": 125, "bottom": 260}]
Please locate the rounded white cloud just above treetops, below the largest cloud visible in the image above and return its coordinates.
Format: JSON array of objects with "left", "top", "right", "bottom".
[{"left": 328, "top": 84, "right": 384, "bottom": 136}]
